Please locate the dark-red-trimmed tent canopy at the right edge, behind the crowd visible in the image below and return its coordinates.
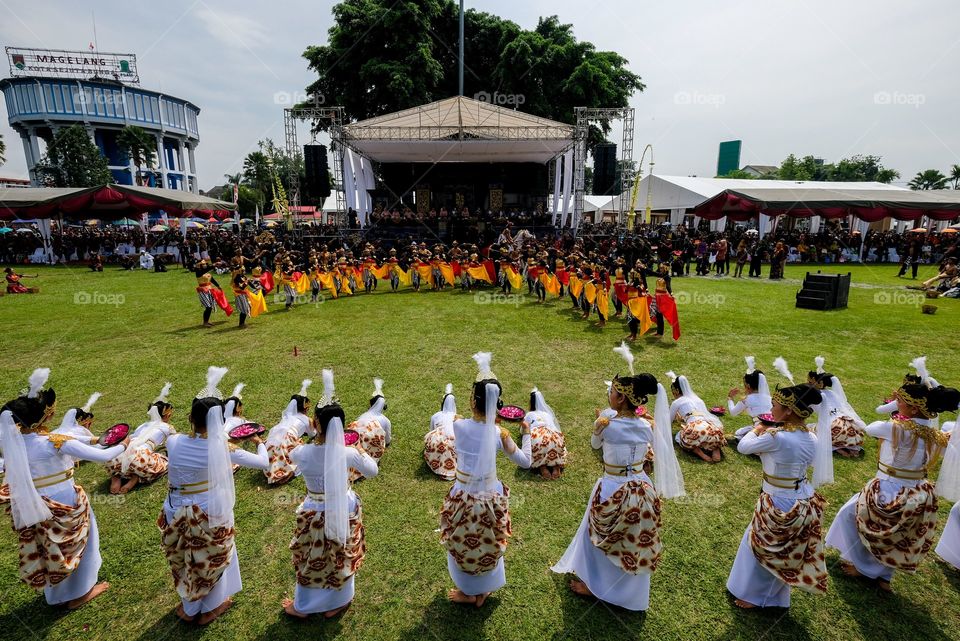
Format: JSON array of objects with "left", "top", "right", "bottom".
[{"left": 692, "top": 184, "right": 960, "bottom": 222}]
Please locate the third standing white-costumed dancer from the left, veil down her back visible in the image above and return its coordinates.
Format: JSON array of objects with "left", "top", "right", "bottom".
[{"left": 283, "top": 370, "right": 377, "bottom": 619}]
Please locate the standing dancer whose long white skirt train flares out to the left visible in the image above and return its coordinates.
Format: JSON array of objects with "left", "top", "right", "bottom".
[{"left": 551, "top": 343, "right": 684, "bottom": 610}]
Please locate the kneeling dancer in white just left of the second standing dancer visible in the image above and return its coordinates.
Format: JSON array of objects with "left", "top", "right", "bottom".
[{"left": 105, "top": 383, "right": 176, "bottom": 494}]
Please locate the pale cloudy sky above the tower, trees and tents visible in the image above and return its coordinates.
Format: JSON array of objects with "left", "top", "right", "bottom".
[{"left": 0, "top": 0, "right": 960, "bottom": 189}]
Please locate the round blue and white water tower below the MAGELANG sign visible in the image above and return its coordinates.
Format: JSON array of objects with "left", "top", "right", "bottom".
[{"left": 0, "top": 47, "right": 200, "bottom": 193}]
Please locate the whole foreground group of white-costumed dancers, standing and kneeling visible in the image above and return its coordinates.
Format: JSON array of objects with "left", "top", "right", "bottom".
[{"left": 0, "top": 344, "right": 960, "bottom": 625}]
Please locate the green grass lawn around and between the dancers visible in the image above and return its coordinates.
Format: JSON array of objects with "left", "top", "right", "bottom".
[{"left": 0, "top": 265, "right": 960, "bottom": 641}]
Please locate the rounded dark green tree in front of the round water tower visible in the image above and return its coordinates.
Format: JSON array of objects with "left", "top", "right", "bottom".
[{"left": 36, "top": 125, "right": 114, "bottom": 187}]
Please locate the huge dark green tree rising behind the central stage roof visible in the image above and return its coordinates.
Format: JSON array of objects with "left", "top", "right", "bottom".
[{"left": 303, "top": 0, "right": 644, "bottom": 142}]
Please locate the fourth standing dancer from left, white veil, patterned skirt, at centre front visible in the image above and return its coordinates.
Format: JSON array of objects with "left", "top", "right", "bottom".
[{"left": 440, "top": 352, "right": 531, "bottom": 608}]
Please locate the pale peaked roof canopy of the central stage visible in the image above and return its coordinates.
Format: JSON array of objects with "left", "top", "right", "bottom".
[{"left": 343, "top": 96, "right": 573, "bottom": 163}]
